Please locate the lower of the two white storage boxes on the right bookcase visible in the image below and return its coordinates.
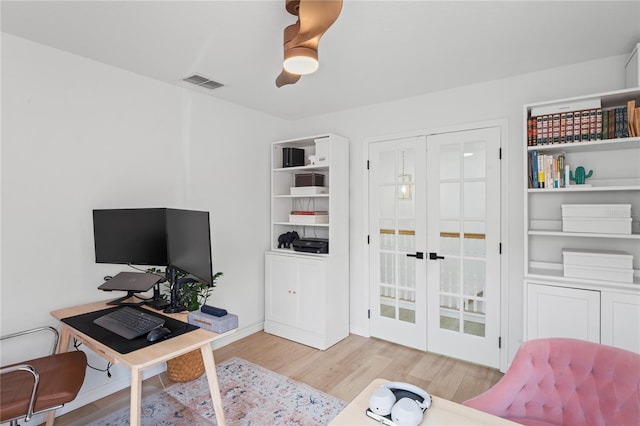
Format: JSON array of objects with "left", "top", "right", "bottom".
[{"left": 562, "top": 249, "right": 633, "bottom": 283}]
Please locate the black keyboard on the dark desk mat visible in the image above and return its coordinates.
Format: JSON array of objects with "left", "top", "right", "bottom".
[{"left": 93, "top": 306, "right": 164, "bottom": 340}]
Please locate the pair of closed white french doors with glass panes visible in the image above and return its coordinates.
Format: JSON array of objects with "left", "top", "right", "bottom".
[{"left": 369, "top": 127, "right": 501, "bottom": 367}]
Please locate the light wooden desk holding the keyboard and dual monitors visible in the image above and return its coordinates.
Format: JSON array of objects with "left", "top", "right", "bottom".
[{"left": 47, "top": 302, "right": 226, "bottom": 426}]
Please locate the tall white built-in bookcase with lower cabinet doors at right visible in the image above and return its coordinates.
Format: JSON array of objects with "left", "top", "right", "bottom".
[{"left": 523, "top": 88, "right": 640, "bottom": 353}]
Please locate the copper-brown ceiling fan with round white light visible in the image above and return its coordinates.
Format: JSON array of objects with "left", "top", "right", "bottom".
[{"left": 276, "top": 0, "right": 342, "bottom": 87}]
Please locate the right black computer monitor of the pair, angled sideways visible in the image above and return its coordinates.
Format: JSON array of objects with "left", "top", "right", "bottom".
[{"left": 166, "top": 209, "right": 213, "bottom": 286}]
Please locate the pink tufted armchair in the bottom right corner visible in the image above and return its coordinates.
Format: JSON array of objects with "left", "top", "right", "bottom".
[{"left": 463, "top": 338, "right": 640, "bottom": 426}]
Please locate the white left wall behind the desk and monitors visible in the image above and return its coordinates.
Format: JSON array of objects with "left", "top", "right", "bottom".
[{"left": 0, "top": 34, "right": 289, "bottom": 420}]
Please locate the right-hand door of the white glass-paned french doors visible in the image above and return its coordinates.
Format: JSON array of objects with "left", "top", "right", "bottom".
[{"left": 427, "top": 127, "right": 500, "bottom": 368}]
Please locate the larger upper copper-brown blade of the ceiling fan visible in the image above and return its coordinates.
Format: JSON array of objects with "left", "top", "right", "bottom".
[{"left": 285, "top": 0, "right": 342, "bottom": 50}]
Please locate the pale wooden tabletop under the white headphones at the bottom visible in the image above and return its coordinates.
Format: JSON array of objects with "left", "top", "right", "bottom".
[{"left": 329, "top": 379, "right": 517, "bottom": 426}]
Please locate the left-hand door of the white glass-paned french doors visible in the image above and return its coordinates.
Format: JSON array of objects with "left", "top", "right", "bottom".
[{"left": 369, "top": 136, "right": 427, "bottom": 350}]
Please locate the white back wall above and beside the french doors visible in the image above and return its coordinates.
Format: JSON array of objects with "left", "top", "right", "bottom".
[{"left": 291, "top": 56, "right": 626, "bottom": 360}]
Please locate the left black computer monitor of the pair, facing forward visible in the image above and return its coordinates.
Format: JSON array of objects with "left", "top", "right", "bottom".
[{"left": 93, "top": 208, "right": 168, "bottom": 266}]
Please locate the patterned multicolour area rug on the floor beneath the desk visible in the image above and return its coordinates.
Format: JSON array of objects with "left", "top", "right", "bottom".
[{"left": 91, "top": 358, "right": 347, "bottom": 426}]
